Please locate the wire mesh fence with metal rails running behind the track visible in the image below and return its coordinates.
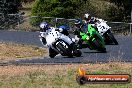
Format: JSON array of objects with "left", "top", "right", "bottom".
[{"left": 0, "top": 14, "right": 132, "bottom": 34}]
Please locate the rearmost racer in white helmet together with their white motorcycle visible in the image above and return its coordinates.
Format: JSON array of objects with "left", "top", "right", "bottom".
[{"left": 84, "top": 13, "right": 118, "bottom": 45}]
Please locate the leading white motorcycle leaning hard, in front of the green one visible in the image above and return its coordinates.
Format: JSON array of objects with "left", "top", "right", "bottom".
[{"left": 40, "top": 27, "right": 82, "bottom": 58}]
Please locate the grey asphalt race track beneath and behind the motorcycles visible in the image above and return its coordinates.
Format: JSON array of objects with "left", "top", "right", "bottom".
[{"left": 0, "top": 30, "right": 132, "bottom": 64}]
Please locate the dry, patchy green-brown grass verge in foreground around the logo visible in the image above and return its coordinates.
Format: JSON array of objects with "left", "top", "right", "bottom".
[{"left": 0, "top": 63, "right": 132, "bottom": 88}]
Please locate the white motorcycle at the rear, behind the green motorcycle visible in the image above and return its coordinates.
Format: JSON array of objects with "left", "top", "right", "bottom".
[{"left": 96, "top": 19, "right": 118, "bottom": 45}]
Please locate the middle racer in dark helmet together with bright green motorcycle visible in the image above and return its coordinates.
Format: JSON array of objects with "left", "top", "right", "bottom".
[{"left": 75, "top": 15, "right": 106, "bottom": 52}]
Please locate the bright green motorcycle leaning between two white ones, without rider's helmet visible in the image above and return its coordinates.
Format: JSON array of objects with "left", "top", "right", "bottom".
[{"left": 75, "top": 24, "right": 106, "bottom": 52}]
